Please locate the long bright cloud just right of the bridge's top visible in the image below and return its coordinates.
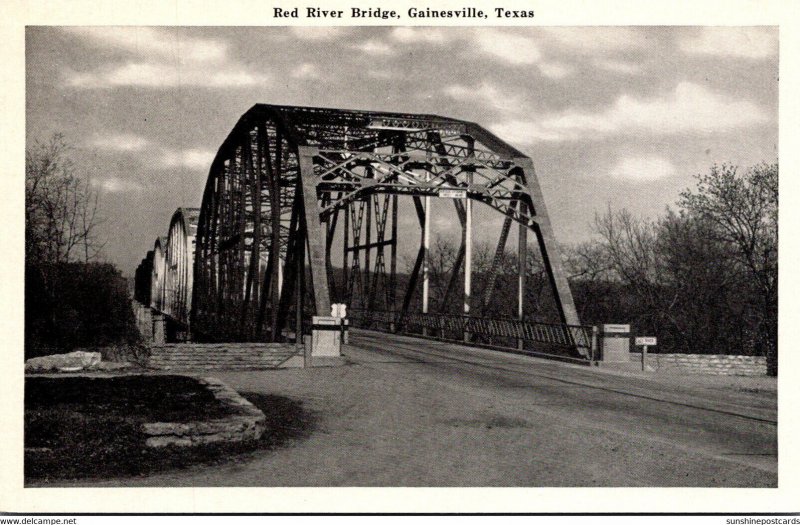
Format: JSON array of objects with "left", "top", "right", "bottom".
[{"left": 492, "top": 82, "right": 769, "bottom": 144}]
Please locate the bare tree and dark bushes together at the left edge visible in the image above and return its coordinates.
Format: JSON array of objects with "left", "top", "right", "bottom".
[{"left": 25, "top": 134, "right": 138, "bottom": 357}]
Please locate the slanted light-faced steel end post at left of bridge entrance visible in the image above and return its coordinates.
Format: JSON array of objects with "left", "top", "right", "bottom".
[{"left": 297, "top": 146, "right": 331, "bottom": 315}]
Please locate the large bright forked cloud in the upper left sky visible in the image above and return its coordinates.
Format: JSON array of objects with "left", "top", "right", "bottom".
[{"left": 64, "top": 27, "right": 269, "bottom": 89}]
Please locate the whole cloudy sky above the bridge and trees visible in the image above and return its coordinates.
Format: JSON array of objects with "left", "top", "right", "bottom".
[{"left": 26, "top": 27, "right": 778, "bottom": 273}]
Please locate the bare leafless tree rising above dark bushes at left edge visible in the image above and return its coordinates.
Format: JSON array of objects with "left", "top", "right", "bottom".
[{"left": 25, "top": 133, "right": 102, "bottom": 263}]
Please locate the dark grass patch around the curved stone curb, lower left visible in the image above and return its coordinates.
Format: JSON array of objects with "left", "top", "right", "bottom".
[{"left": 24, "top": 376, "right": 312, "bottom": 483}]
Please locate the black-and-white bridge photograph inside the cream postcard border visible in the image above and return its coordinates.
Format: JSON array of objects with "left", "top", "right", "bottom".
[{"left": 0, "top": 2, "right": 796, "bottom": 512}]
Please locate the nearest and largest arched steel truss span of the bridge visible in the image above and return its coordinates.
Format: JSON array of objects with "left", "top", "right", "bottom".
[{"left": 192, "top": 104, "right": 579, "bottom": 354}]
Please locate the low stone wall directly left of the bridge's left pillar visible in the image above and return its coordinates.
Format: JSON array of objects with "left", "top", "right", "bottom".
[{"left": 147, "top": 343, "right": 303, "bottom": 370}]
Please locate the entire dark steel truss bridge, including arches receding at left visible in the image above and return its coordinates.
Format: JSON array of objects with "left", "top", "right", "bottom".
[{"left": 136, "top": 104, "right": 592, "bottom": 360}]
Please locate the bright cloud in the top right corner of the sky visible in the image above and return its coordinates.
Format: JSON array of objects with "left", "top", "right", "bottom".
[{"left": 678, "top": 27, "right": 778, "bottom": 59}]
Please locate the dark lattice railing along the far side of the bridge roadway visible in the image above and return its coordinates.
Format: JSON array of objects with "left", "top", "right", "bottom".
[{"left": 348, "top": 309, "right": 594, "bottom": 361}]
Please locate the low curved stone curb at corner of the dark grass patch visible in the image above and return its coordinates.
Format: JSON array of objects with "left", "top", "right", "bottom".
[{"left": 142, "top": 377, "right": 266, "bottom": 447}]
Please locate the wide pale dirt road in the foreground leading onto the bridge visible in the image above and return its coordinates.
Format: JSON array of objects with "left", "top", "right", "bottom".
[{"left": 65, "top": 332, "right": 777, "bottom": 487}]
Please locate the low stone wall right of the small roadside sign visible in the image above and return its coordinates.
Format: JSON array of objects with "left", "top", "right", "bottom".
[{"left": 648, "top": 354, "right": 767, "bottom": 376}]
